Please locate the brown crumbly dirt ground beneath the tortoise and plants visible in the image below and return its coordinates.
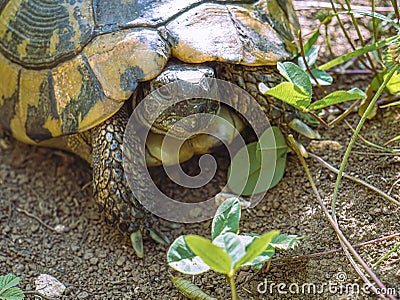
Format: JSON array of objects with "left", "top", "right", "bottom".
[{"left": 0, "top": 2, "right": 400, "bottom": 299}]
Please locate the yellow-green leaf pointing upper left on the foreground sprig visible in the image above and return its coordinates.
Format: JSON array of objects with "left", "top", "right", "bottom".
[{"left": 185, "top": 235, "right": 232, "bottom": 274}]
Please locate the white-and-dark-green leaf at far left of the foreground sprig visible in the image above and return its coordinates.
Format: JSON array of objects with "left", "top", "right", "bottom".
[{"left": 167, "top": 236, "right": 210, "bottom": 275}]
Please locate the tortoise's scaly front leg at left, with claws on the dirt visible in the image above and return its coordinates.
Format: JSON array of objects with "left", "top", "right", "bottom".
[{"left": 91, "top": 106, "right": 166, "bottom": 257}]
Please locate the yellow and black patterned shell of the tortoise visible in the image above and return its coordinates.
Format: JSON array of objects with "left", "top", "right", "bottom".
[{"left": 0, "top": 0, "right": 298, "bottom": 143}]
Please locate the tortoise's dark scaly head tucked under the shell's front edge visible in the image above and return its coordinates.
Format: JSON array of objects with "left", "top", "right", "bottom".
[{"left": 140, "top": 64, "right": 220, "bottom": 139}]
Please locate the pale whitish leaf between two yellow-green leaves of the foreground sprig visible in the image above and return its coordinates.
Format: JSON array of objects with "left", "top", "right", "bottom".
[{"left": 213, "top": 232, "right": 246, "bottom": 269}]
